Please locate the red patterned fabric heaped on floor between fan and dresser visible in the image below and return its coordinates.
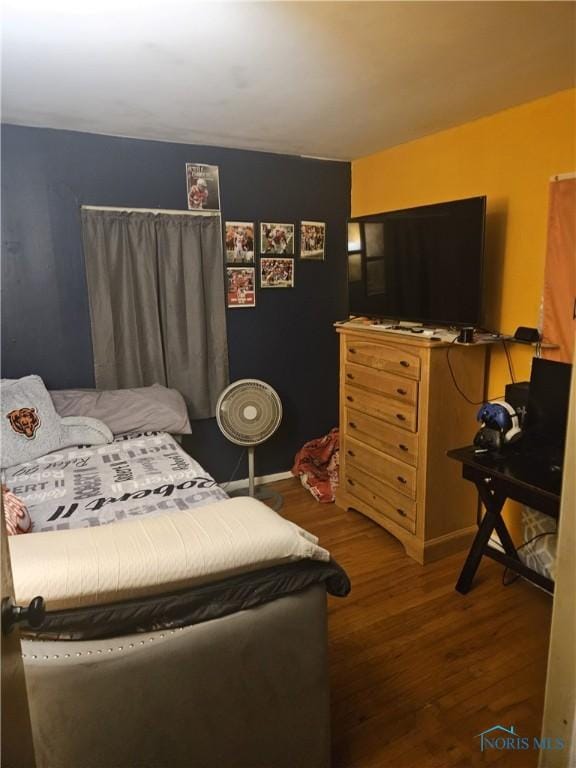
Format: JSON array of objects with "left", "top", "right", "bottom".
[{"left": 292, "top": 428, "right": 340, "bottom": 503}]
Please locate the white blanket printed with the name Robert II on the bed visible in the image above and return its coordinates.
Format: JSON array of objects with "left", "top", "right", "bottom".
[{"left": 3, "top": 432, "right": 228, "bottom": 533}]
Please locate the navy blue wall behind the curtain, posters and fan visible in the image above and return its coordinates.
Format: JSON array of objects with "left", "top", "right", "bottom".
[{"left": 2, "top": 126, "right": 350, "bottom": 480}]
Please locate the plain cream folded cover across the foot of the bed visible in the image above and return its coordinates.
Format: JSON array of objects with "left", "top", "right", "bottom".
[{"left": 9, "top": 498, "right": 330, "bottom": 610}]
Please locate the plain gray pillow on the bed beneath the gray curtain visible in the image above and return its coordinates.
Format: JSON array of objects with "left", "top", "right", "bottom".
[{"left": 50, "top": 384, "right": 192, "bottom": 435}]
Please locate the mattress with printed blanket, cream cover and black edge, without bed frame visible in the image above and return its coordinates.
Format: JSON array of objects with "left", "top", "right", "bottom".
[{"left": 4, "top": 433, "right": 350, "bottom": 639}]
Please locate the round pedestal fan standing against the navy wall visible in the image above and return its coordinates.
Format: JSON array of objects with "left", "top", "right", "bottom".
[{"left": 216, "top": 379, "right": 282, "bottom": 510}]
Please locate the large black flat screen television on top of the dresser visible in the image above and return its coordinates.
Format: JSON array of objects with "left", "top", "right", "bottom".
[{"left": 348, "top": 197, "right": 486, "bottom": 326}]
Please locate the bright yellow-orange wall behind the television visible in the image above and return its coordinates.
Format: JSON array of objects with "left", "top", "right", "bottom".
[{"left": 352, "top": 90, "right": 576, "bottom": 397}]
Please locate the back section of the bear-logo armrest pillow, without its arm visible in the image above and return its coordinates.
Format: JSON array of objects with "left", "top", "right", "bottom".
[{"left": 0, "top": 376, "right": 60, "bottom": 467}]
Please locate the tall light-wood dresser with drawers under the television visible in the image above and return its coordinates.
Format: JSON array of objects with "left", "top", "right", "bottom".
[{"left": 336, "top": 322, "right": 487, "bottom": 563}]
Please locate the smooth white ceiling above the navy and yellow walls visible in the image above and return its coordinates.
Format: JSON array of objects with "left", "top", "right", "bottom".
[{"left": 2, "top": 0, "right": 576, "bottom": 159}]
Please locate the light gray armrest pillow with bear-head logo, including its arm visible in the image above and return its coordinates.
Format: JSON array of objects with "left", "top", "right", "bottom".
[{"left": 0, "top": 376, "right": 114, "bottom": 468}]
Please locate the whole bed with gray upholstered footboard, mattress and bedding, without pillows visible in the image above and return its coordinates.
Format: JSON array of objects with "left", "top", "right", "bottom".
[{"left": 3, "top": 404, "right": 350, "bottom": 768}]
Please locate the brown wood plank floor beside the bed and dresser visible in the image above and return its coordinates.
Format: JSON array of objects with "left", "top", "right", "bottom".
[{"left": 274, "top": 480, "right": 552, "bottom": 768}]
